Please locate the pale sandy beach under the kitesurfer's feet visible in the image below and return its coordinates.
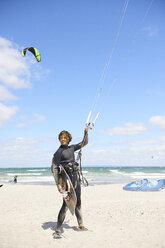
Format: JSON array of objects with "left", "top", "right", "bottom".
[{"left": 0, "top": 184, "right": 165, "bottom": 248}]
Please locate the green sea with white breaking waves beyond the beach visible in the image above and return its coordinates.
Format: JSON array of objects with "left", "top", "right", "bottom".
[{"left": 0, "top": 166, "right": 165, "bottom": 185}]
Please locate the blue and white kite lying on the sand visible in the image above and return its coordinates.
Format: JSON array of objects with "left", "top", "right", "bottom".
[{"left": 123, "top": 178, "right": 165, "bottom": 191}]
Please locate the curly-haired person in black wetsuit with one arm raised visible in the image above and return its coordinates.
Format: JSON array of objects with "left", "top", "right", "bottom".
[{"left": 51, "top": 127, "right": 89, "bottom": 239}]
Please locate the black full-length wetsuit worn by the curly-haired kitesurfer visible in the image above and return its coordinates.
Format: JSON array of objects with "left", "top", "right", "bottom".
[{"left": 51, "top": 131, "right": 88, "bottom": 229}]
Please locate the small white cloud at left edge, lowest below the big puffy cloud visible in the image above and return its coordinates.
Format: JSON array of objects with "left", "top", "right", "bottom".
[{"left": 0, "top": 103, "right": 18, "bottom": 127}]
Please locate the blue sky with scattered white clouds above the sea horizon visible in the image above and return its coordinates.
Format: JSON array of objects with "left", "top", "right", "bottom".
[{"left": 0, "top": 0, "right": 165, "bottom": 168}]
